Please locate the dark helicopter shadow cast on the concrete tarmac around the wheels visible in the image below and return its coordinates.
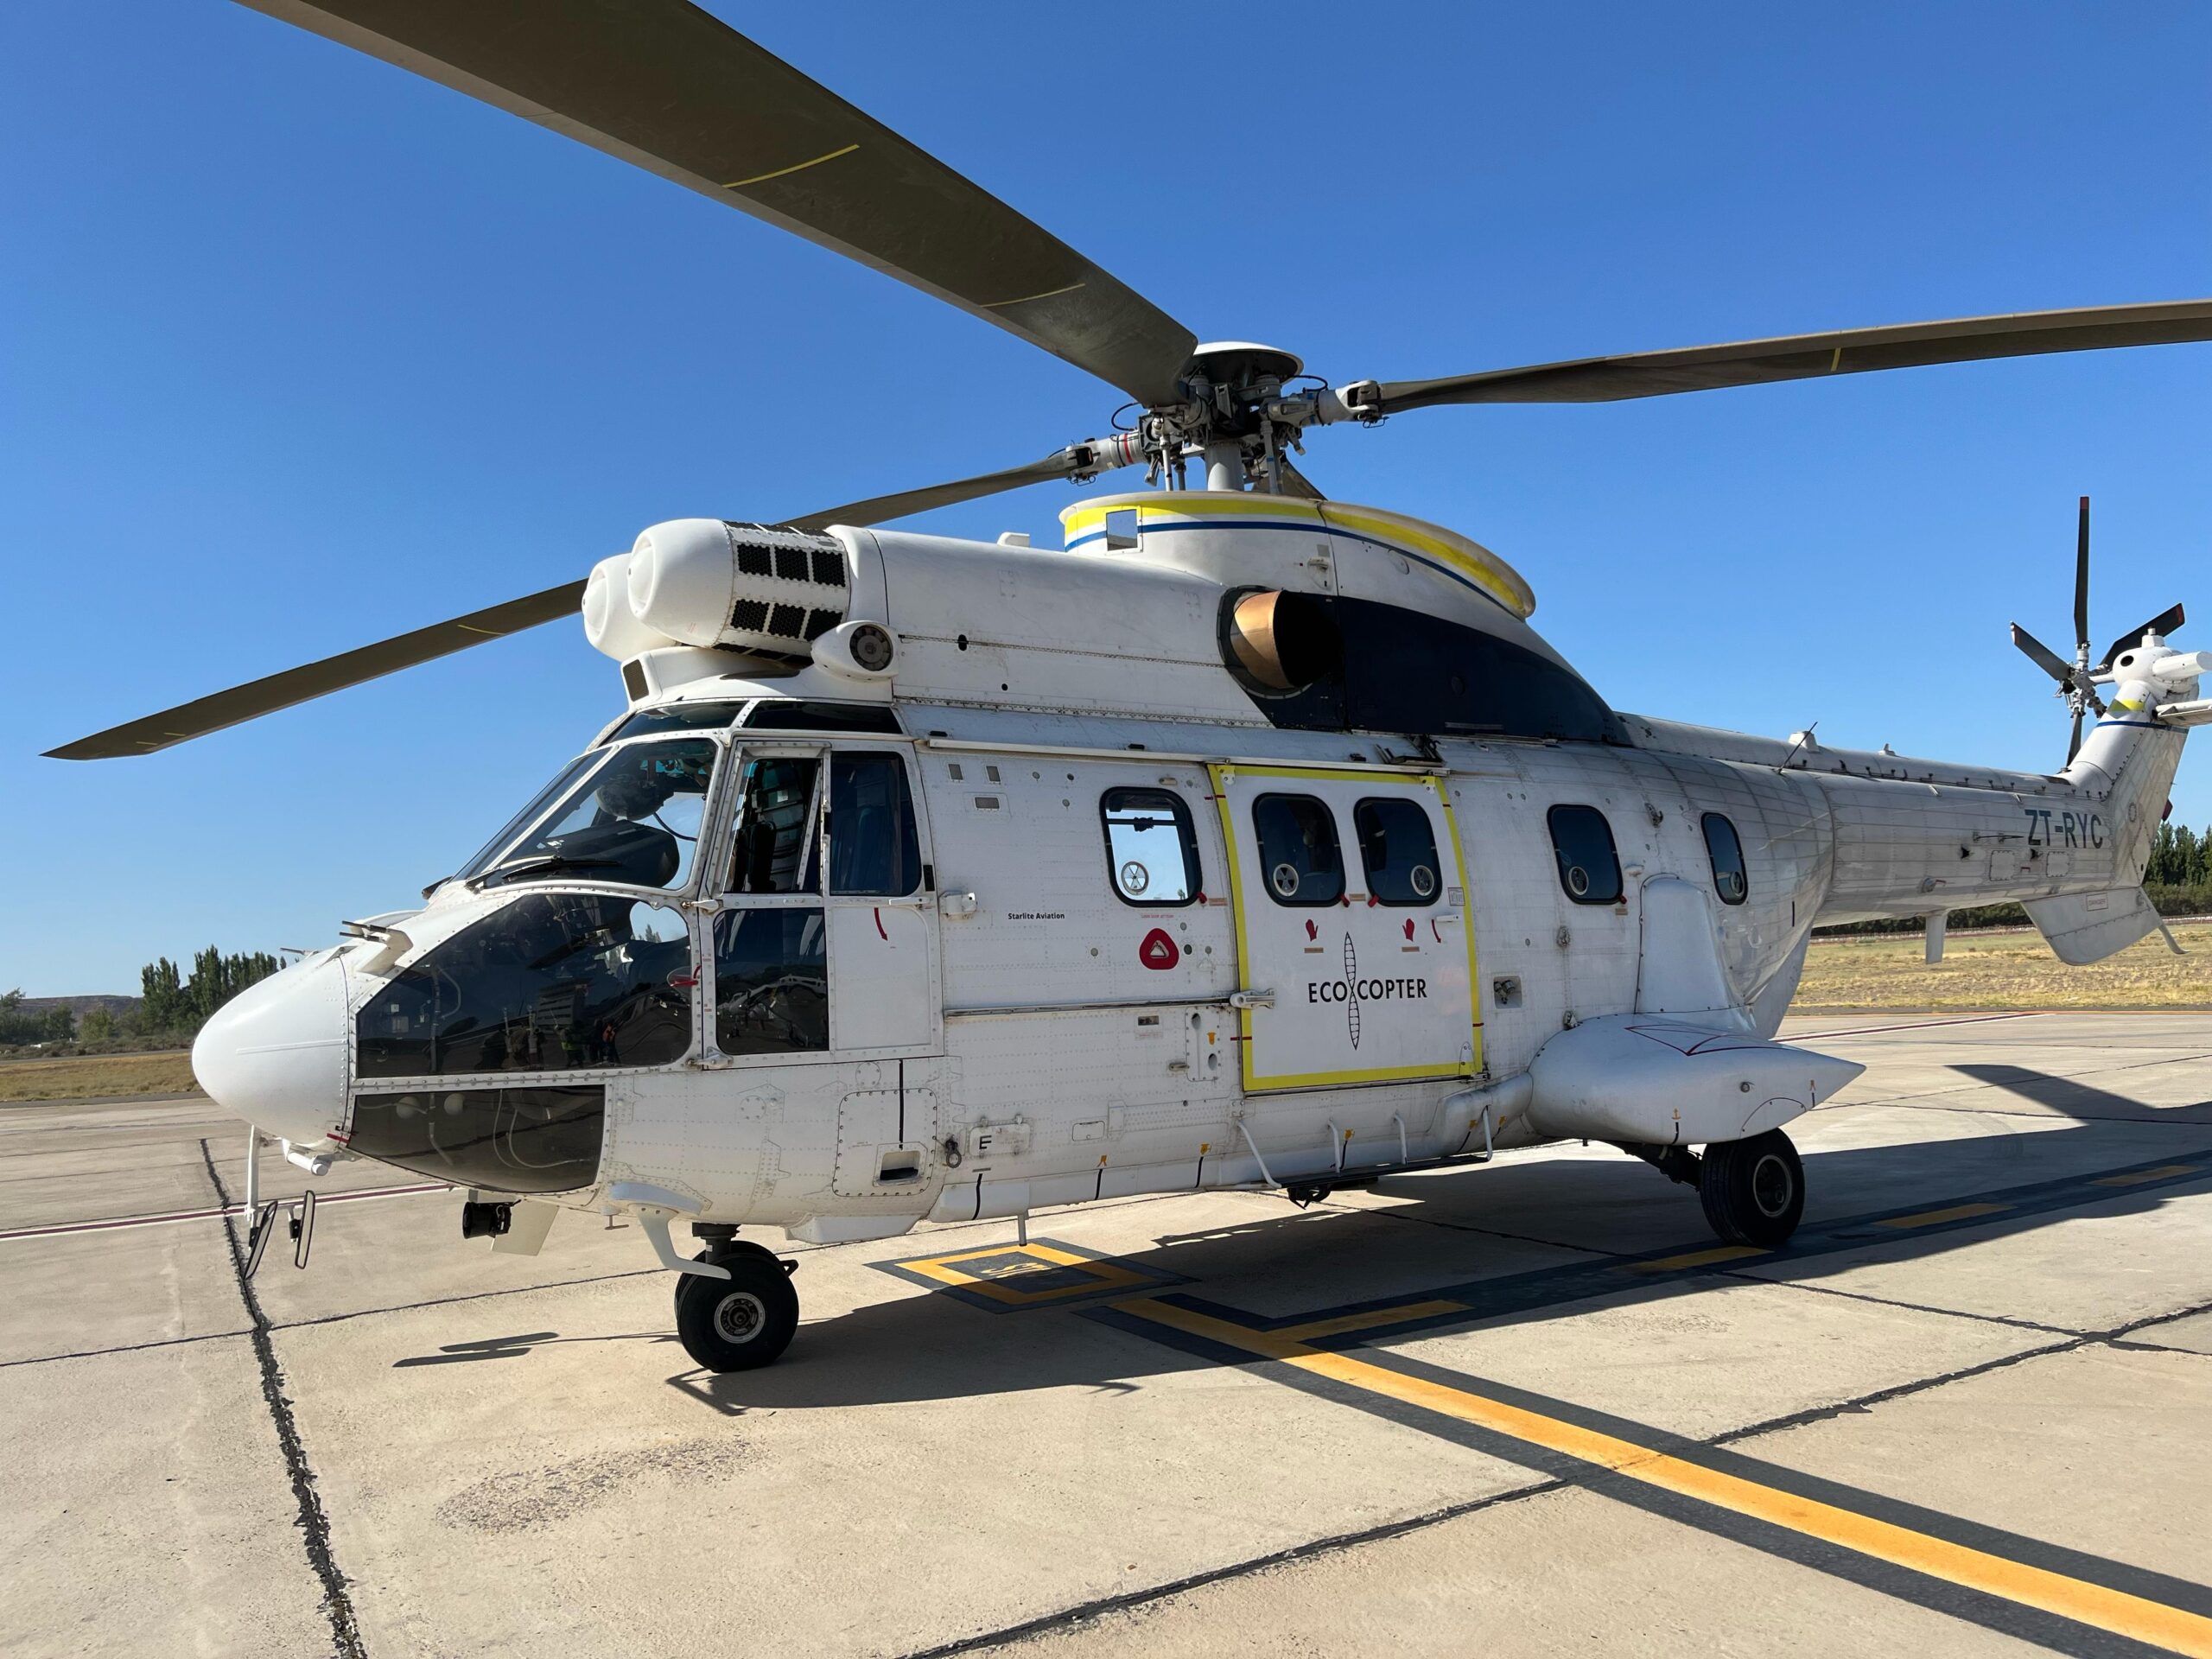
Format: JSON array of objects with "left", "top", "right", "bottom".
[{"left": 628, "top": 1066, "right": 2212, "bottom": 1415}]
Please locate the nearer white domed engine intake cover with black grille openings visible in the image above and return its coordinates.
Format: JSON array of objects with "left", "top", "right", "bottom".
[{"left": 628, "top": 518, "right": 852, "bottom": 659}]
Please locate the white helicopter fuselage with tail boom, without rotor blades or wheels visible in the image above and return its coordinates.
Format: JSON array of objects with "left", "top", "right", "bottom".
[{"left": 194, "top": 493, "right": 2196, "bottom": 1265}]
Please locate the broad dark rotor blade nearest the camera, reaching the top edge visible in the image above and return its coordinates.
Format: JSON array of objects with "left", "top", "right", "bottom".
[{"left": 244, "top": 0, "right": 1197, "bottom": 404}]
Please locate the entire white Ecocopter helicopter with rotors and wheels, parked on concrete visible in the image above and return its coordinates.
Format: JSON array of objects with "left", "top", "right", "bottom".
[{"left": 51, "top": 0, "right": 2212, "bottom": 1371}]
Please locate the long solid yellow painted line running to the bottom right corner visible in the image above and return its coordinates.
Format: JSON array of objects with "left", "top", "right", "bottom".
[{"left": 1115, "top": 1299, "right": 2212, "bottom": 1659}]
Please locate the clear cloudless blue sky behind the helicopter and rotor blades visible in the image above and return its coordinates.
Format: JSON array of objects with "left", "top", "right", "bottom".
[{"left": 0, "top": 0, "right": 2212, "bottom": 995}]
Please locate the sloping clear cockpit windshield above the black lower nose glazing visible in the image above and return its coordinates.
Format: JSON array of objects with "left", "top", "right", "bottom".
[{"left": 460, "top": 736, "right": 721, "bottom": 889}]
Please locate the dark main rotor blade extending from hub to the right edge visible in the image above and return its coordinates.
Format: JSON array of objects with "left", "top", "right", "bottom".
[{"left": 1344, "top": 299, "right": 2212, "bottom": 414}]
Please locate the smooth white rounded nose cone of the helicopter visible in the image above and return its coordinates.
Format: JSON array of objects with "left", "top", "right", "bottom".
[{"left": 193, "top": 956, "right": 349, "bottom": 1141}]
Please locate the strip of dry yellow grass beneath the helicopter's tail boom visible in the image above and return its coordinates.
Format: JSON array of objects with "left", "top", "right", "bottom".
[{"left": 1792, "top": 923, "right": 2212, "bottom": 1013}]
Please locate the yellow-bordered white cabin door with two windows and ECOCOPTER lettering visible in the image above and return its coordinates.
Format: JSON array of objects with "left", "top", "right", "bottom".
[{"left": 1210, "top": 766, "right": 1482, "bottom": 1090}]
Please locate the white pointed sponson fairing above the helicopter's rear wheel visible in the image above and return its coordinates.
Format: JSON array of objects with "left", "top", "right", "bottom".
[{"left": 1529, "top": 1013, "right": 1865, "bottom": 1146}]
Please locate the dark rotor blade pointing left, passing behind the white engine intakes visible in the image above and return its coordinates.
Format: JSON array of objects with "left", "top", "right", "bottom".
[{"left": 47, "top": 435, "right": 1139, "bottom": 761}]
